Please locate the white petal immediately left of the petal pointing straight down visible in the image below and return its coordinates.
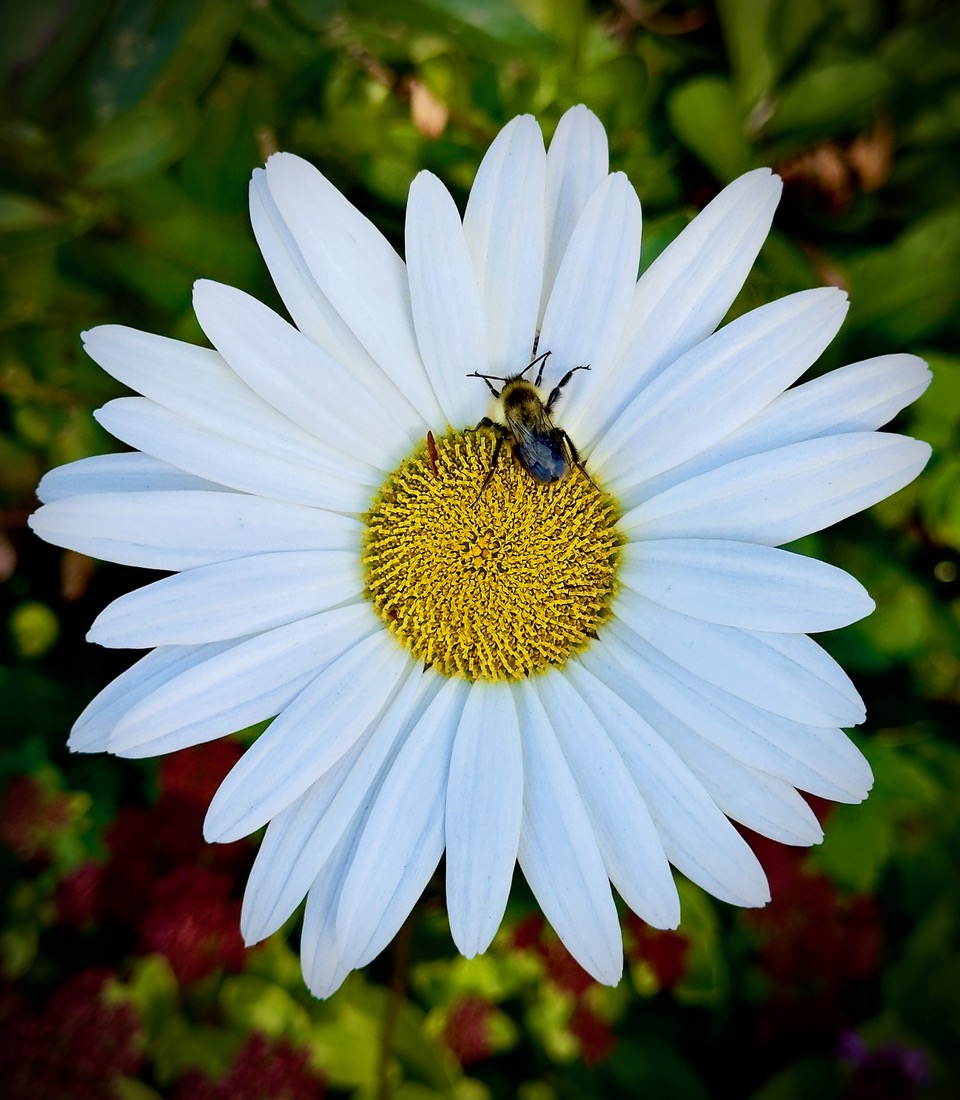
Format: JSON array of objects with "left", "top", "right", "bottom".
[{"left": 336, "top": 680, "right": 467, "bottom": 966}]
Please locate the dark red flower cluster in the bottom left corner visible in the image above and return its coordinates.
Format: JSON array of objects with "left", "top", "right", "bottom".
[{"left": 0, "top": 970, "right": 143, "bottom": 1100}]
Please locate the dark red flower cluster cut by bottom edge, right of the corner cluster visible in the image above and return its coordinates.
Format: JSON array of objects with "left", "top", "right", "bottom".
[{"left": 174, "top": 1032, "right": 323, "bottom": 1100}]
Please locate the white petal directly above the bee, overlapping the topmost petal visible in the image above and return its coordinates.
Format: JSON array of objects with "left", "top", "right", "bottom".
[{"left": 538, "top": 172, "right": 640, "bottom": 404}]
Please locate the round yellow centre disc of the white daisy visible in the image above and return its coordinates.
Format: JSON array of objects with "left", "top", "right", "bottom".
[{"left": 364, "top": 429, "right": 621, "bottom": 680}]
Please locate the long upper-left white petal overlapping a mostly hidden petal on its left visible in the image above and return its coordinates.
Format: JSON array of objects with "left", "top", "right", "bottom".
[{"left": 260, "top": 153, "right": 442, "bottom": 424}]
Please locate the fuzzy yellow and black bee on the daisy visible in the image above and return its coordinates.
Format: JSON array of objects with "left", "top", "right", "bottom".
[{"left": 467, "top": 351, "right": 589, "bottom": 498}]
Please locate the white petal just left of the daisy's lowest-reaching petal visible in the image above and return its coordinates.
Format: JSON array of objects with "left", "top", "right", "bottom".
[{"left": 240, "top": 666, "right": 440, "bottom": 944}]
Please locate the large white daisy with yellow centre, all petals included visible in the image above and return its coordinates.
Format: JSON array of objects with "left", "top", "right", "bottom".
[{"left": 32, "top": 107, "right": 929, "bottom": 997}]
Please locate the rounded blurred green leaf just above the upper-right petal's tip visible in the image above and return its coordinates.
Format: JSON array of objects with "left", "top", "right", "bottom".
[{"left": 666, "top": 76, "right": 752, "bottom": 183}]
